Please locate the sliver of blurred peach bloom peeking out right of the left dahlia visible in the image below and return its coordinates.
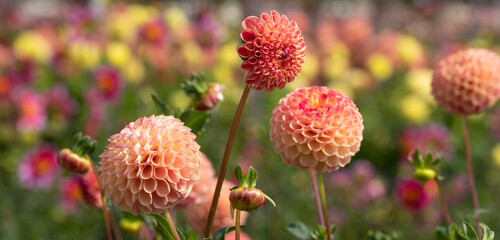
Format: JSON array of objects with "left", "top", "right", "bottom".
[{"left": 177, "top": 153, "right": 216, "bottom": 207}]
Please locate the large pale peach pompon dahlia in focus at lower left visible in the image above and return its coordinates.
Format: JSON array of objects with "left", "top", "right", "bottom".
[{"left": 99, "top": 115, "right": 201, "bottom": 214}]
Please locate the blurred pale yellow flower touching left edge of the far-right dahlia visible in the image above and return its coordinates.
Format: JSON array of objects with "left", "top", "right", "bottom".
[{"left": 405, "top": 68, "right": 435, "bottom": 103}]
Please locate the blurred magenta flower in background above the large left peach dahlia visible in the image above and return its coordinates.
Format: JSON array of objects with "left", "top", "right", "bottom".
[{"left": 94, "top": 66, "right": 122, "bottom": 101}]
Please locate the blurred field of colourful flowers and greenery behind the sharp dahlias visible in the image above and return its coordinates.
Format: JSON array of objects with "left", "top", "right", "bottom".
[{"left": 0, "top": 0, "right": 500, "bottom": 240}]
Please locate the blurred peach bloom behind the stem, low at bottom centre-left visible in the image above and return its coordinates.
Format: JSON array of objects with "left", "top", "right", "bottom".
[{"left": 185, "top": 181, "right": 248, "bottom": 235}]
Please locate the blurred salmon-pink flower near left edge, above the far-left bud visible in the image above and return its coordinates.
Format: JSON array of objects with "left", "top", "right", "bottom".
[{"left": 16, "top": 89, "right": 47, "bottom": 132}]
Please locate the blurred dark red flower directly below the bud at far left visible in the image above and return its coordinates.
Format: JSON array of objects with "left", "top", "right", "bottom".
[{"left": 61, "top": 177, "right": 83, "bottom": 213}]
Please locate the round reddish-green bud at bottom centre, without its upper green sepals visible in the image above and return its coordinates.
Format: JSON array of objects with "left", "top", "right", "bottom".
[{"left": 229, "top": 187, "right": 266, "bottom": 212}]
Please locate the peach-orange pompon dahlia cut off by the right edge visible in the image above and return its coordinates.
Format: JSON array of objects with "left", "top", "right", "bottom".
[{"left": 432, "top": 49, "right": 500, "bottom": 115}]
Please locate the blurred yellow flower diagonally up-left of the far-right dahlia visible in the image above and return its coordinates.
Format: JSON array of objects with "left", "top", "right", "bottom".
[{"left": 396, "top": 35, "right": 424, "bottom": 65}]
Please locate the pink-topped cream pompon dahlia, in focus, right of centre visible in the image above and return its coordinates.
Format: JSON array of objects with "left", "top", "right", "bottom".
[{"left": 270, "top": 87, "right": 364, "bottom": 173}]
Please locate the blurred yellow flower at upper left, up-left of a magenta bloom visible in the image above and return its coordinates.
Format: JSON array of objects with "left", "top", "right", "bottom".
[{"left": 69, "top": 39, "right": 102, "bottom": 69}]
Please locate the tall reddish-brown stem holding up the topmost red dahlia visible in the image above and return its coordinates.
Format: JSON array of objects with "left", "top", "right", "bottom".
[{"left": 205, "top": 85, "right": 251, "bottom": 237}]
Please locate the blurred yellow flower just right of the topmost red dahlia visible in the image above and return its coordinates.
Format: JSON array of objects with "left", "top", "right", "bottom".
[{"left": 322, "top": 42, "right": 350, "bottom": 79}]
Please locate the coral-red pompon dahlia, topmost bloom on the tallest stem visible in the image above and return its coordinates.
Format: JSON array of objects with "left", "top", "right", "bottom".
[{"left": 238, "top": 11, "right": 306, "bottom": 91}]
